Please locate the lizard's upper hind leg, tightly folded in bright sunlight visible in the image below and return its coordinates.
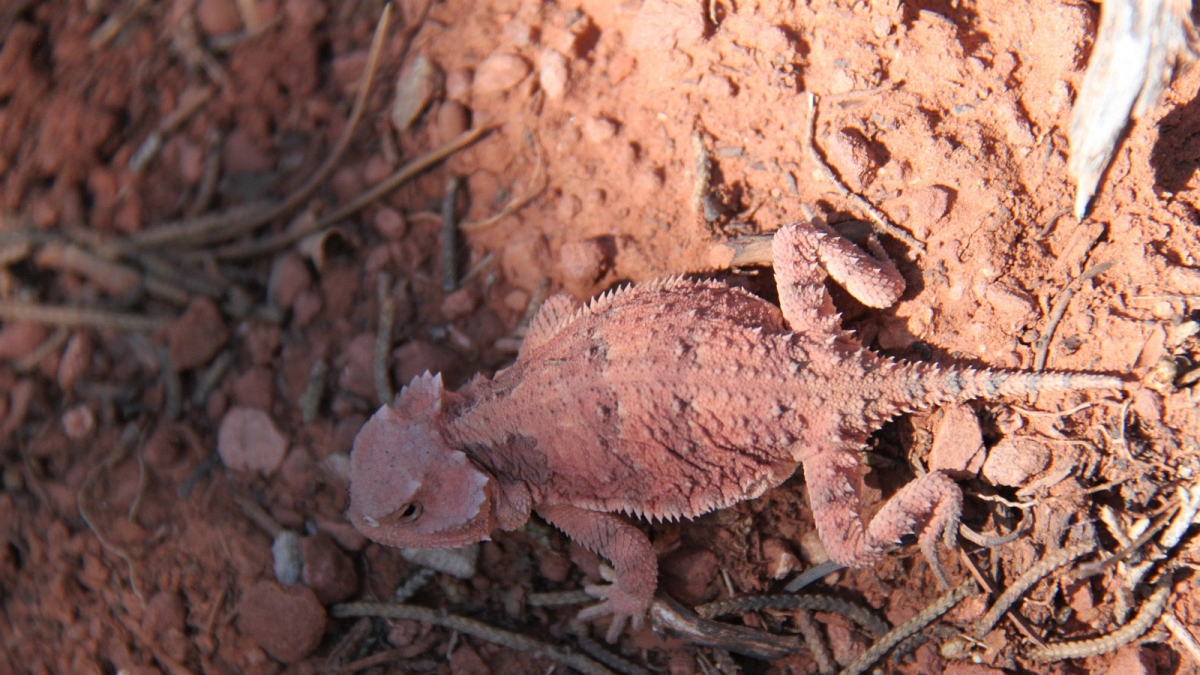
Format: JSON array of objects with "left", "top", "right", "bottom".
[{"left": 772, "top": 220, "right": 905, "bottom": 338}]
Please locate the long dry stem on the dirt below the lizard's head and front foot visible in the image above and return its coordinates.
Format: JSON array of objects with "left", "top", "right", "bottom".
[{"left": 330, "top": 603, "right": 612, "bottom": 675}]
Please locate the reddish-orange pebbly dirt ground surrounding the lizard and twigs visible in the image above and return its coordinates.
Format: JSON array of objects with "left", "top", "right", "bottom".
[{"left": 0, "top": 0, "right": 1200, "bottom": 675}]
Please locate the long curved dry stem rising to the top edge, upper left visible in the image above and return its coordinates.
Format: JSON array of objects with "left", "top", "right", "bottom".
[{"left": 130, "top": 2, "right": 391, "bottom": 247}]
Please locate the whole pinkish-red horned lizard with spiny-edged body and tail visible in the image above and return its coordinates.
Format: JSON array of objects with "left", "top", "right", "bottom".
[{"left": 349, "top": 222, "right": 1122, "bottom": 641}]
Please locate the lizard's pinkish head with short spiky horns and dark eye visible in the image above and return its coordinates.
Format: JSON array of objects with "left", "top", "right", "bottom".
[{"left": 349, "top": 372, "right": 496, "bottom": 548}]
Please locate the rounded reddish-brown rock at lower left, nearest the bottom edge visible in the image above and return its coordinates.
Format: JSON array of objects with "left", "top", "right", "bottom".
[{"left": 238, "top": 581, "right": 328, "bottom": 663}]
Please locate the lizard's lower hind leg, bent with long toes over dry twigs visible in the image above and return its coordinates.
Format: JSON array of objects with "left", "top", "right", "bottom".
[{"left": 803, "top": 447, "right": 962, "bottom": 587}]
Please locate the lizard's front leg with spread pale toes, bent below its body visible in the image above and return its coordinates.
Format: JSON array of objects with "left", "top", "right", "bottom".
[{"left": 536, "top": 504, "right": 659, "bottom": 644}]
